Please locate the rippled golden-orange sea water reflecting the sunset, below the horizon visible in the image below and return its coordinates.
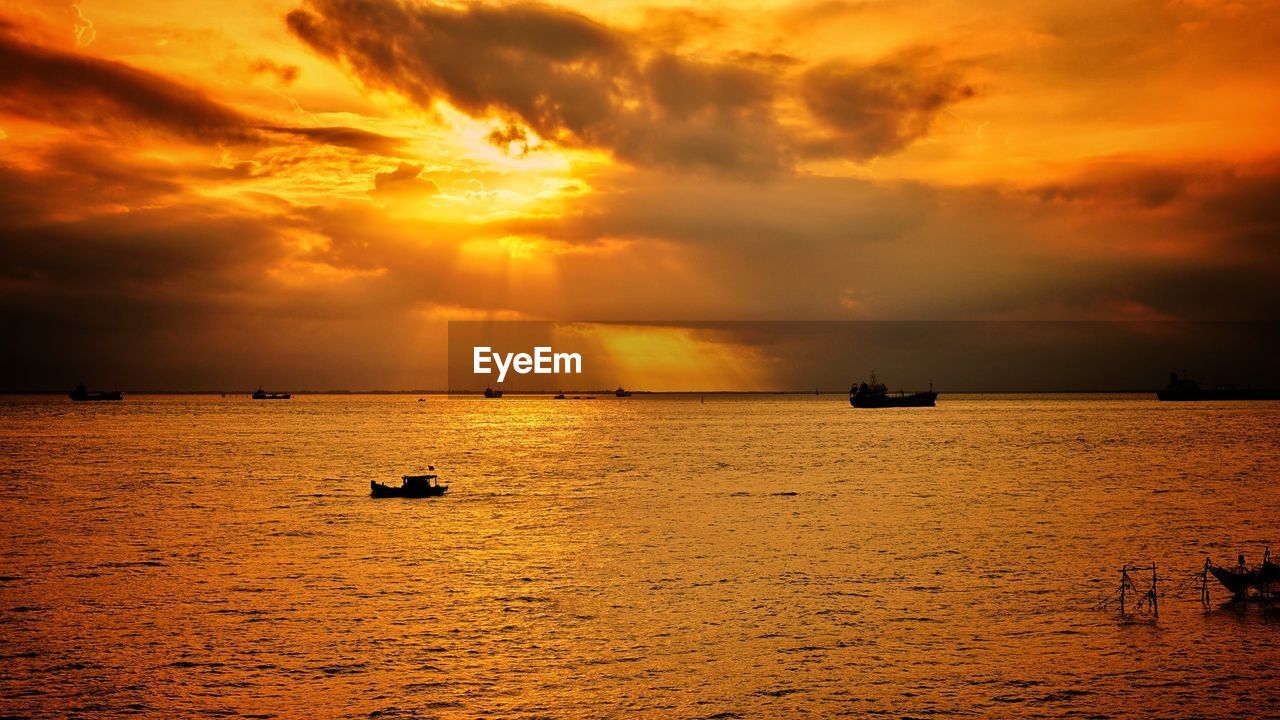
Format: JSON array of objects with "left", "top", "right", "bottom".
[{"left": 0, "top": 396, "right": 1280, "bottom": 717}]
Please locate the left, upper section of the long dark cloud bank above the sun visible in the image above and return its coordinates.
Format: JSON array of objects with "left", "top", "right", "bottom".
[{"left": 287, "top": 0, "right": 631, "bottom": 137}]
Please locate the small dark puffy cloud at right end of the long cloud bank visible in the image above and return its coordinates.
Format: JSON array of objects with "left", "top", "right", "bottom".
[{"left": 800, "top": 53, "right": 974, "bottom": 159}]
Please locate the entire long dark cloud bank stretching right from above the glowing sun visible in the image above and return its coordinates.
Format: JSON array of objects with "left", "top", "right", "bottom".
[{"left": 287, "top": 0, "right": 973, "bottom": 174}]
